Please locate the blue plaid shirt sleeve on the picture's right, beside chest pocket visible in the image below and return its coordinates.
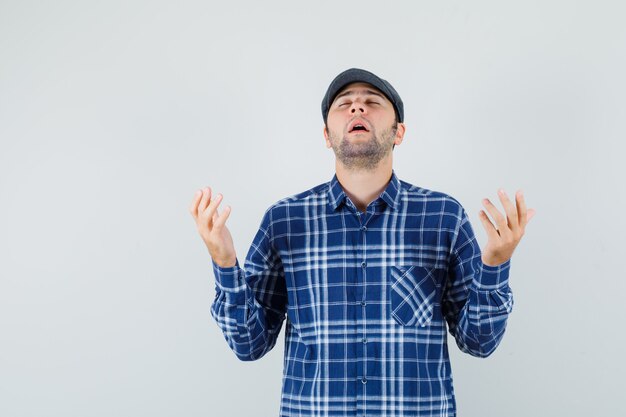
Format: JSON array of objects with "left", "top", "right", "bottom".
[{"left": 443, "top": 203, "right": 513, "bottom": 357}]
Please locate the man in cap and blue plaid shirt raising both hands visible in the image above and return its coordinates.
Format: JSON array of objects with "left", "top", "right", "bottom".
[{"left": 190, "top": 68, "right": 534, "bottom": 417}]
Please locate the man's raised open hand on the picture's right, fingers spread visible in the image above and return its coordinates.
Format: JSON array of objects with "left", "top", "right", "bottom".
[{"left": 479, "top": 189, "right": 536, "bottom": 266}]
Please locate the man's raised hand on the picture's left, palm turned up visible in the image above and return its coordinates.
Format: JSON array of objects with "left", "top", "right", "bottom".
[{"left": 189, "top": 187, "right": 237, "bottom": 268}]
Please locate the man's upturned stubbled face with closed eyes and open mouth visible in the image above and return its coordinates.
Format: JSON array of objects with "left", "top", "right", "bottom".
[{"left": 324, "top": 83, "right": 404, "bottom": 170}]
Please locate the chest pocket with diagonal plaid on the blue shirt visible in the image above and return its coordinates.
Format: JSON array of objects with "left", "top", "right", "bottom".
[{"left": 389, "top": 265, "right": 441, "bottom": 326}]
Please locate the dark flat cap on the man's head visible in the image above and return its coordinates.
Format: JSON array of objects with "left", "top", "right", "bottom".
[{"left": 322, "top": 68, "right": 404, "bottom": 123}]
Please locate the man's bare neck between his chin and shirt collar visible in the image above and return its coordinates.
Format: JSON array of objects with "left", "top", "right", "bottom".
[{"left": 335, "top": 154, "right": 392, "bottom": 212}]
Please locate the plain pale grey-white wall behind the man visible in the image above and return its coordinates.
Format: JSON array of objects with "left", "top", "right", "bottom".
[{"left": 0, "top": 0, "right": 626, "bottom": 417}]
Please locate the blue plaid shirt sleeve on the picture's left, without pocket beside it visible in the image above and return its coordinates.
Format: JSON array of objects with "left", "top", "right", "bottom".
[{"left": 211, "top": 209, "right": 287, "bottom": 361}]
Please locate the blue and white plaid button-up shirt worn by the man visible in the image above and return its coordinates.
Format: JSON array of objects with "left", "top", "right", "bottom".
[{"left": 211, "top": 171, "right": 513, "bottom": 417}]
